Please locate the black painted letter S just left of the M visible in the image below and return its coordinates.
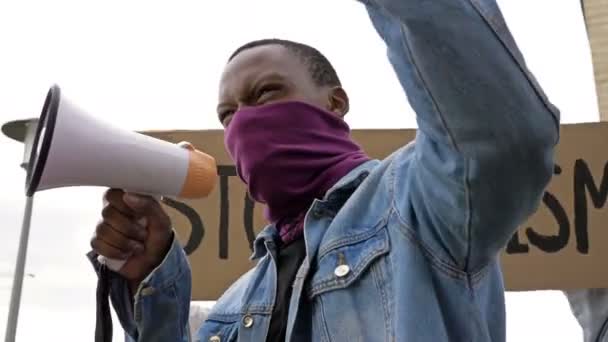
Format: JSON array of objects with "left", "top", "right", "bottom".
[{"left": 526, "top": 192, "right": 570, "bottom": 253}]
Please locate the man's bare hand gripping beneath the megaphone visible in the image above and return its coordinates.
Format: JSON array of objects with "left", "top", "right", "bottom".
[{"left": 91, "top": 189, "right": 173, "bottom": 287}]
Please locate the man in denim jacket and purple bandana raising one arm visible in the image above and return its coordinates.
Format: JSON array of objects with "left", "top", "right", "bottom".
[{"left": 92, "top": 0, "right": 559, "bottom": 342}]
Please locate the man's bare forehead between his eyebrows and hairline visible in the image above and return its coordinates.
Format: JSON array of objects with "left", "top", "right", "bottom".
[{"left": 220, "top": 44, "right": 310, "bottom": 97}]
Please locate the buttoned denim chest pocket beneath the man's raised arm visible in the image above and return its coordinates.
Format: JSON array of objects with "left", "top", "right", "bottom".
[{"left": 307, "top": 227, "right": 392, "bottom": 342}]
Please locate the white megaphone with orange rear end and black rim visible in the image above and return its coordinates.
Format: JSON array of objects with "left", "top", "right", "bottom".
[{"left": 26, "top": 85, "right": 217, "bottom": 269}]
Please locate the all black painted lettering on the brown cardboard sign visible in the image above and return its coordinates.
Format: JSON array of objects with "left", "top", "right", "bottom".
[{"left": 164, "top": 159, "right": 608, "bottom": 259}]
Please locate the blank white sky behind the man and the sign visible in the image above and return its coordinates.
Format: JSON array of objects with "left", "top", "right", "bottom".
[{"left": 0, "top": 0, "right": 599, "bottom": 342}]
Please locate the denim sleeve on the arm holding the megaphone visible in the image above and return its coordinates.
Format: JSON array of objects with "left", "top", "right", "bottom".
[{"left": 89, "top": 234, "right": 192, "bottom": 342}]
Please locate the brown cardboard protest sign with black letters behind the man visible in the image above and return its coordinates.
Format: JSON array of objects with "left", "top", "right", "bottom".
[{"left": 148, "top": 123, "right": 608, "bottom": 300}]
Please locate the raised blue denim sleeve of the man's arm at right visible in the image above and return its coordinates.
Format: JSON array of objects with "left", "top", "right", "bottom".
[{"left": 362, "top": 0, "right": 559, "bottom": 272}]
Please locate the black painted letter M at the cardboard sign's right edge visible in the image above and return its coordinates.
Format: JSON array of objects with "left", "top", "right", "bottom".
[{"left": 574, "top": 159, "right": 608, "bottom": 254}]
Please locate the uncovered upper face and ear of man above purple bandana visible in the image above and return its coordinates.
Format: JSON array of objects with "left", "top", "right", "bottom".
[{"left": 217, "top": 44, "right": 348, "bottom": 127}]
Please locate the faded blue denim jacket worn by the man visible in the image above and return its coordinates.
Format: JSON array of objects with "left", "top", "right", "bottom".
[{"left": 101, "top": 0, "right": 559, "bottom": 342}]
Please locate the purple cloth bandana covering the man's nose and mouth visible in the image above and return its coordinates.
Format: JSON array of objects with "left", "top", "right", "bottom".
[{"left": 225, "top": 101, "right": 368, "bottom": 242}]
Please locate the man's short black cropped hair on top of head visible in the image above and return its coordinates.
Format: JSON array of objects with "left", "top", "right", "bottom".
[{"left": 228, "top": 38, "right": 342, "bottom": 87}]
